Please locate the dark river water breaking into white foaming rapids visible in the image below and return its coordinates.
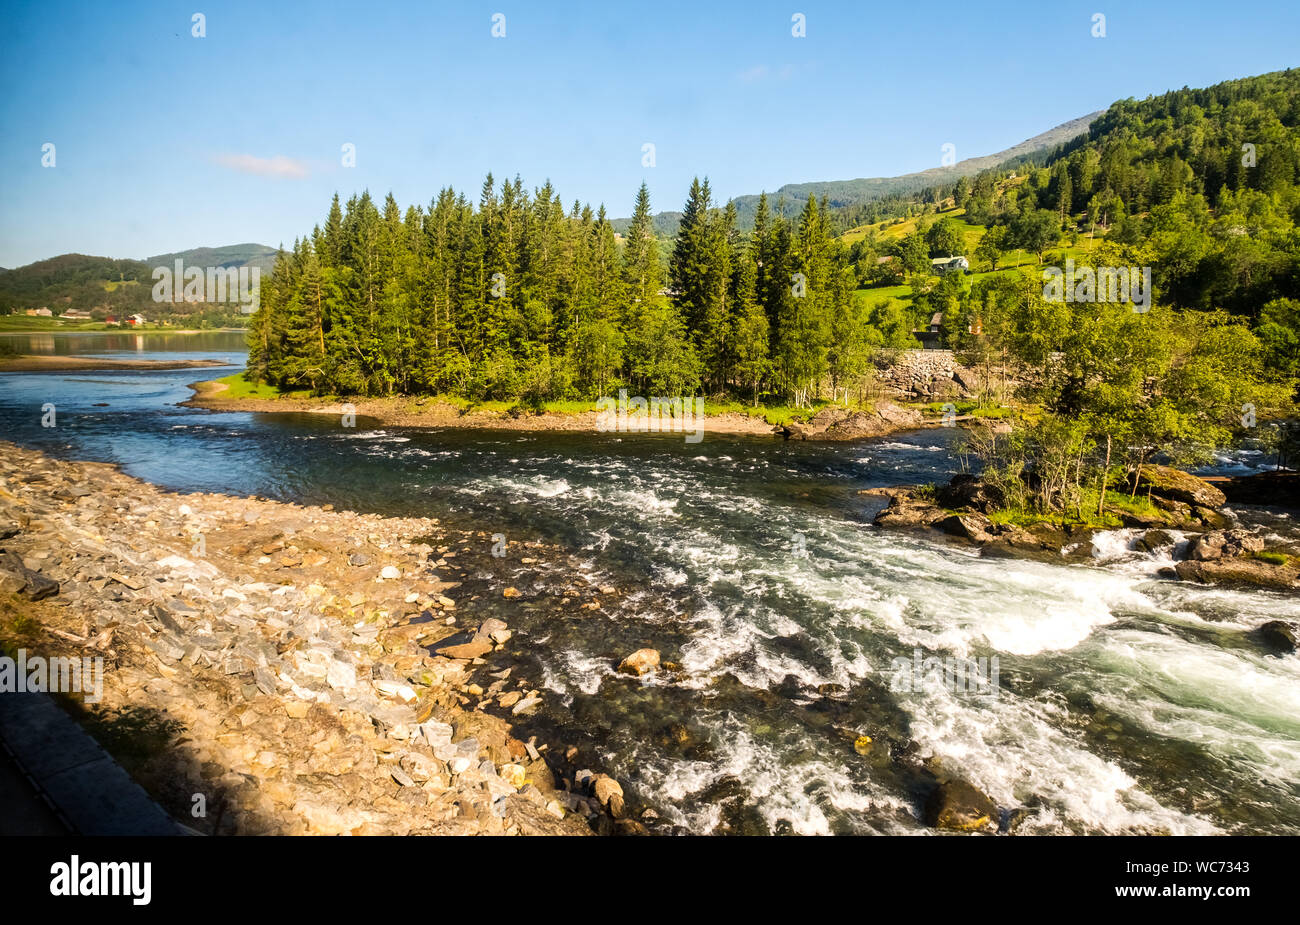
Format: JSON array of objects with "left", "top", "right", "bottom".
[{"left": 0, "top": 334, "right": 1300, "bottom": 834}]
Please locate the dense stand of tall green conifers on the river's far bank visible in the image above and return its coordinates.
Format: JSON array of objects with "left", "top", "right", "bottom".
[{"left": 248, "top": 174, "right": 884, "bottom": 404}]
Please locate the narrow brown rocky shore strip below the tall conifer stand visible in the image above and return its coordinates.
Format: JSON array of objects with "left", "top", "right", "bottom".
[{"left": 179, "top": 379, "right": 941, "bottom": 442}]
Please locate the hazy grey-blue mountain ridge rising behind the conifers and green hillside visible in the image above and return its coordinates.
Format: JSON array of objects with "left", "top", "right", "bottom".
[{"left": 612, "top": 109, "right": 1105, "bottom": 238}]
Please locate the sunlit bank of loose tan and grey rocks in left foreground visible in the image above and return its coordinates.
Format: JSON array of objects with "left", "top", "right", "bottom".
[{"left": 0, "top": 443, "right": 645, "bottom": 834}]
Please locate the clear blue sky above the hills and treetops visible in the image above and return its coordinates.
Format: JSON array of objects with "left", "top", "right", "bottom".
[{"left": 0, "top": 0, "right": 1300, "bottom": 266}]
